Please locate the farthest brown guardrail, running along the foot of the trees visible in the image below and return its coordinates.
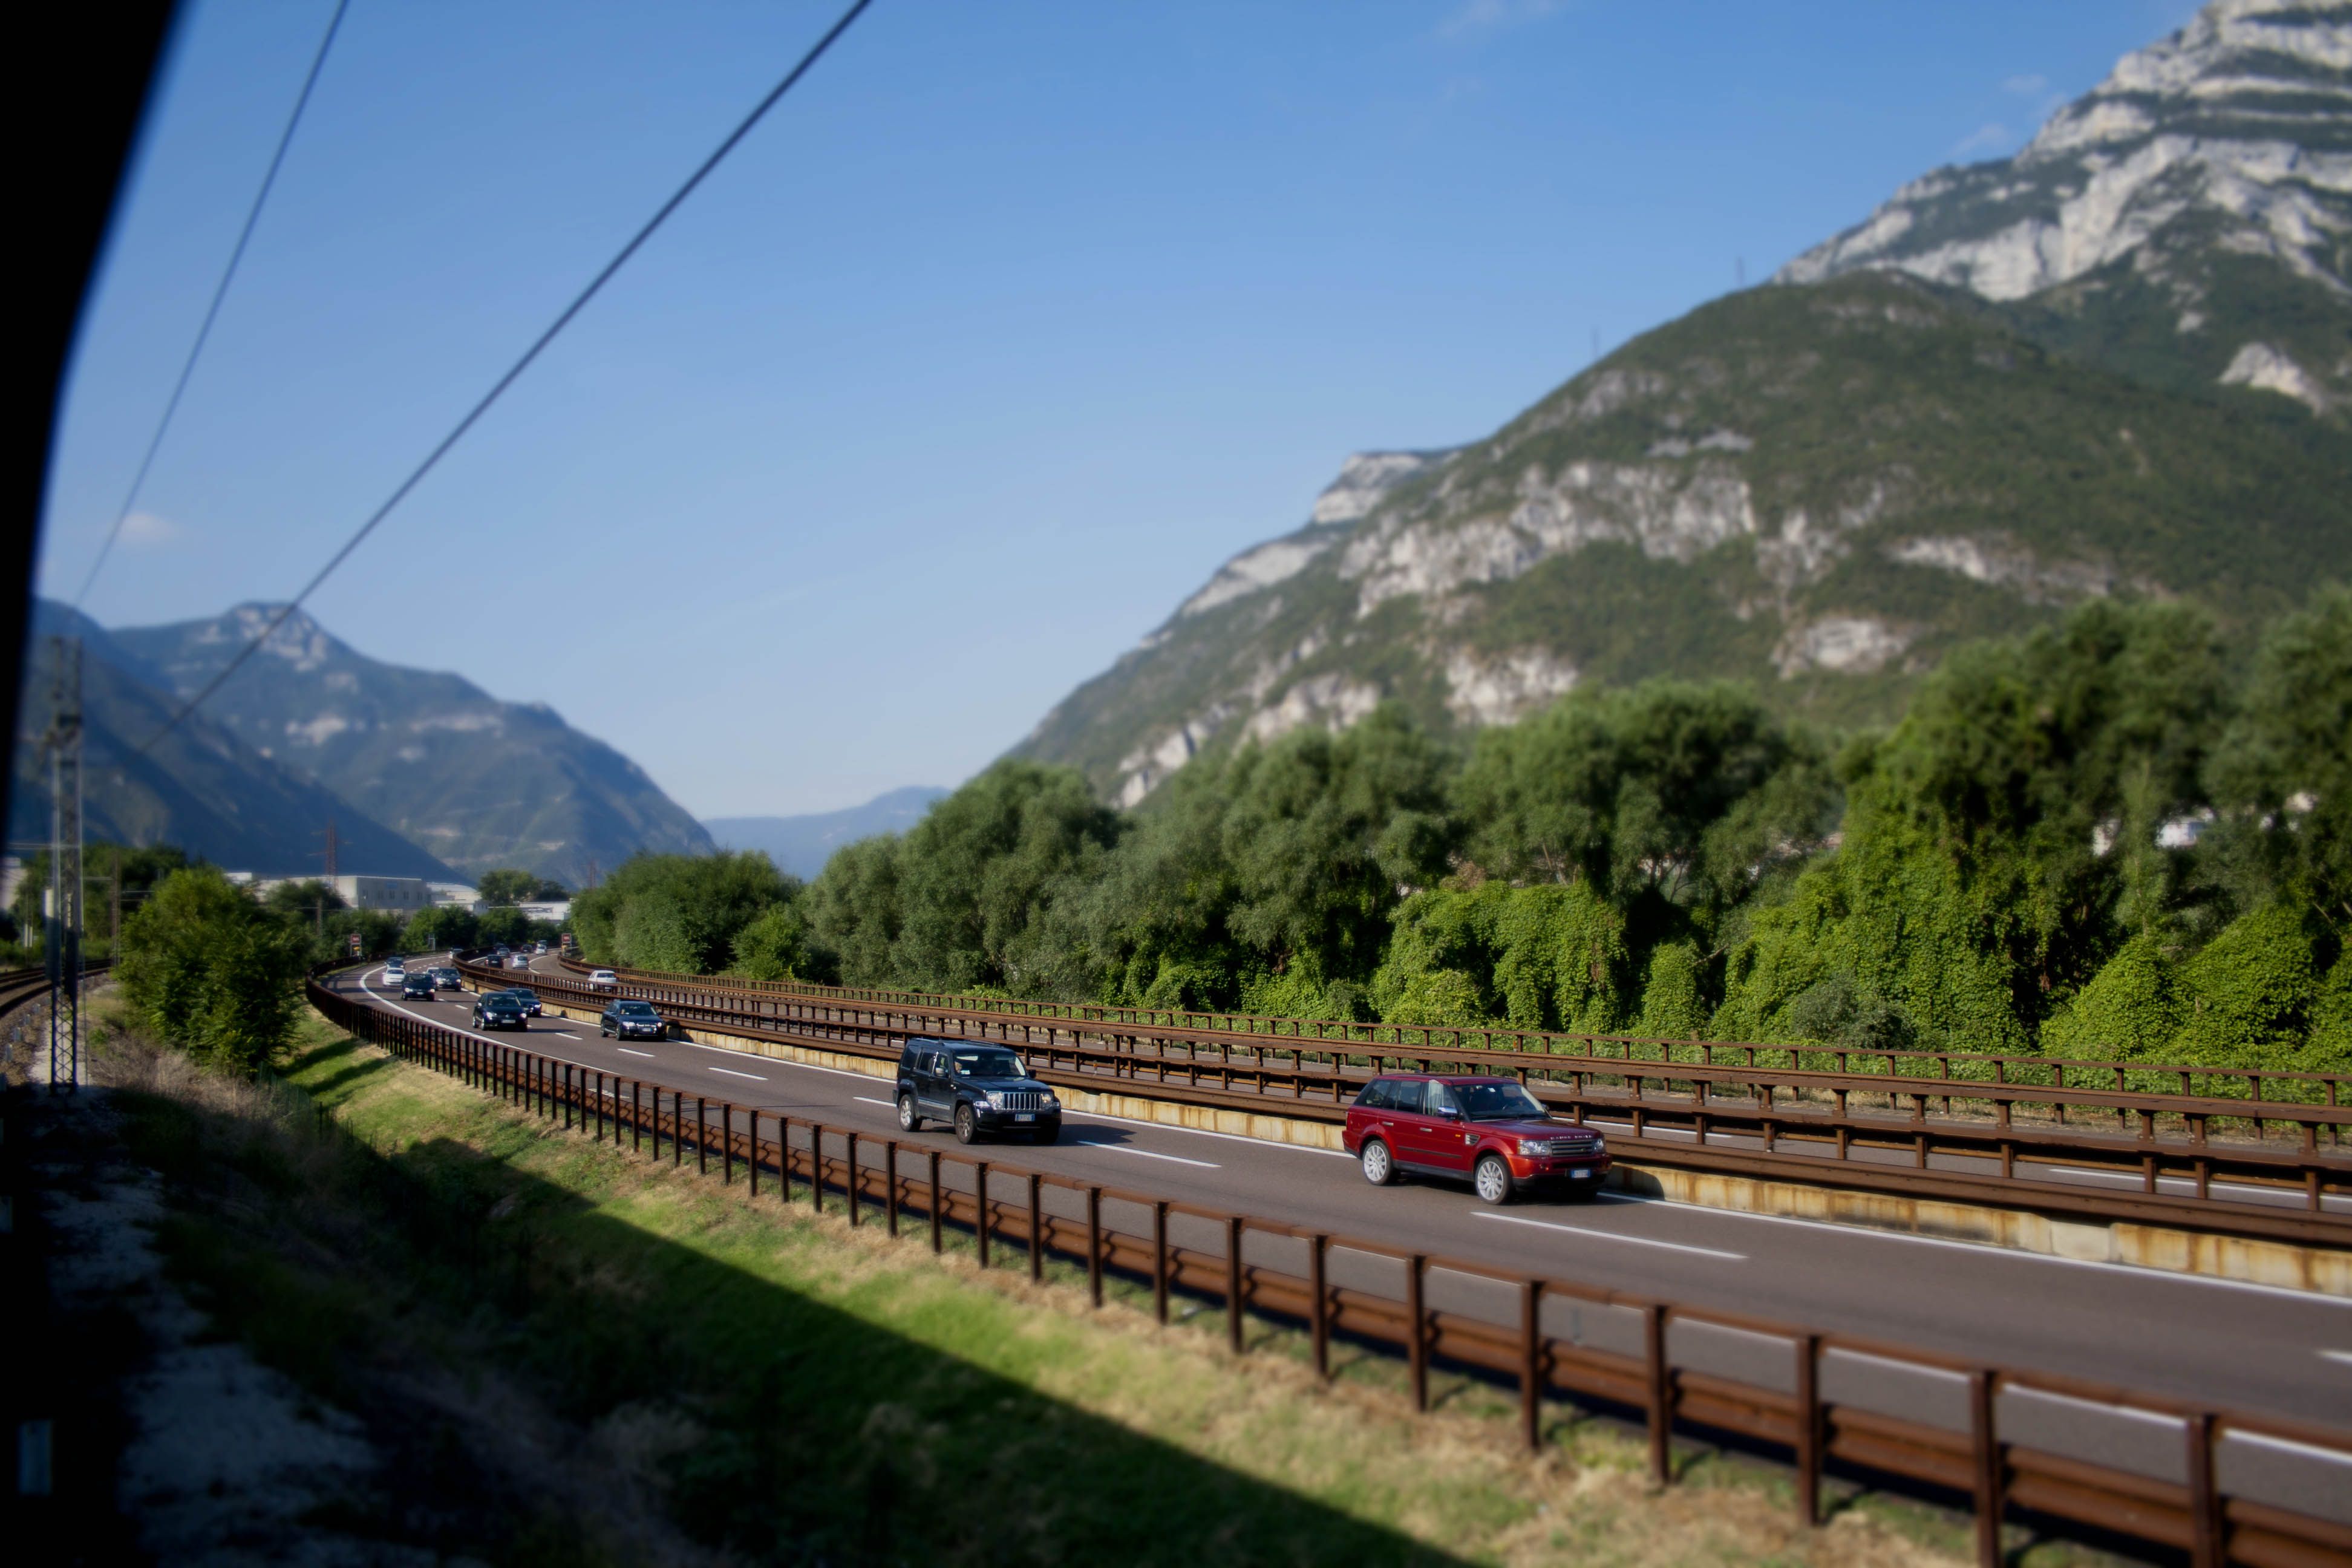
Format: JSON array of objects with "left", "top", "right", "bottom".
[{"left": 555, "top": 955, "right": 2352, "bottom": 1105}]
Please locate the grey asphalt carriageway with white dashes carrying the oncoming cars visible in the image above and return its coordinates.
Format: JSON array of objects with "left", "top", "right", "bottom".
[{"left": 336, "top": 969, "right": 2352, "bottom": 1521}]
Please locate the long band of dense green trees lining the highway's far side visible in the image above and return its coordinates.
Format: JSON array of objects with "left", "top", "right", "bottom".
[{"left": 574, "top": 588, "right": 2352, "bottom": 1070}]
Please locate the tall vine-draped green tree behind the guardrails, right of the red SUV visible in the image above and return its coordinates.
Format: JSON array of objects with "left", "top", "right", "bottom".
[{"left": 1712, "top": 602, "right": 2227, "bottom": 1051}]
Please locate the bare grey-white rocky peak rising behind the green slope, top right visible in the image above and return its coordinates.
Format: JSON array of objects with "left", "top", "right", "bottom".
[{"left": 1778, "top": 0, "right": 2352, "bottom": 419}]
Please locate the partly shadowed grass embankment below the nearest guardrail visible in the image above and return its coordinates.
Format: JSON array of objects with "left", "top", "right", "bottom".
[{"left": 116, "top": 1018, "right": 2004, "bottom": 1563}]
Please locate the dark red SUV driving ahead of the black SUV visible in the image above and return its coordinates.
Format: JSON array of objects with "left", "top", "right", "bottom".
[{"left": 1341, "top": 1074, "right": 1609, "bottom": 1204}]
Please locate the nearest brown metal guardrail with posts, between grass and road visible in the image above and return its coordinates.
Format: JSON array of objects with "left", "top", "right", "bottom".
[{"left": 310, "top": 980, "right": 2352, "bottom": 1568}]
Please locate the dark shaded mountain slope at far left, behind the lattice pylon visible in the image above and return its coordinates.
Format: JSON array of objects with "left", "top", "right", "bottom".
[{"left": 7, "top": 602, "right": 456, "bottom": 879}]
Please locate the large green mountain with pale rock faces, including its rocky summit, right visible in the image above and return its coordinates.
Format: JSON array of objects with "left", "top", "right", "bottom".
[{"left": 1014, "top": 0, "right": 2352, "bottom": 804}]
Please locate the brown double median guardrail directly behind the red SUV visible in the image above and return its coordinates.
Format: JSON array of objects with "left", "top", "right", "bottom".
[{"left": 486, "top": 966, "right": 2352, "bottom": 1248}]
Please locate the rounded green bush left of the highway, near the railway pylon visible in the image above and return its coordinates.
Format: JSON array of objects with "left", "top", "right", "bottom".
[{"left": 117, "top": 867, "right": 310, "bottom": 1072}]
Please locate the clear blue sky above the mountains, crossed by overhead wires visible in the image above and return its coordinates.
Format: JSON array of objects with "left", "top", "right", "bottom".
[{"left": 42, "top": 0, "right": 2192, "bottom": 815}]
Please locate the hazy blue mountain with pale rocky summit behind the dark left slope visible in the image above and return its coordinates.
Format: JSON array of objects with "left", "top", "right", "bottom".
[{"left": 113, "top": 604, "right": 713, "bottom": 886}]
